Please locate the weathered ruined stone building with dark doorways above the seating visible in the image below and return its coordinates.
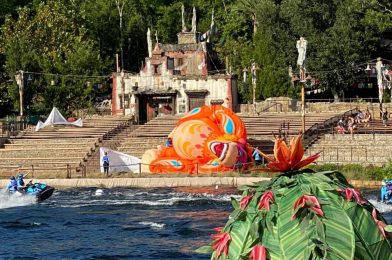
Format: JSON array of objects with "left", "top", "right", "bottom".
[{"left": 112, "top": 9, "right": 238, "bottom": 123}]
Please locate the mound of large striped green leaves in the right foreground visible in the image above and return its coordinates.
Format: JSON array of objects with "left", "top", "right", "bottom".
[{"left": 200, "top": 170, "right": 392, "bottom": 259}]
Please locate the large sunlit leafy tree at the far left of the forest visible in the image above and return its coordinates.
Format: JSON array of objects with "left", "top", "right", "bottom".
[{"left": 1, "top": 1, "right": 102, "bottom": 115}]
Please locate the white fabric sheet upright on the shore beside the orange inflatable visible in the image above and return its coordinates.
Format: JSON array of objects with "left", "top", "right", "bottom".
[{"left": 99, "top": 147, "right": 141, "bottom": 173}]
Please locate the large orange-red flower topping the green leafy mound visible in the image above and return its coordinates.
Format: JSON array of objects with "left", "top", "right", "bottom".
[{"left": 259, "top": 134, "right": 320, "bottom": 172}]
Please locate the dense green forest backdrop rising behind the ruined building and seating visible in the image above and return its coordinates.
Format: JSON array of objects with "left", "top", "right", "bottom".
[{"left": 0, "top": 0, "right": 392, "bottom": 116}]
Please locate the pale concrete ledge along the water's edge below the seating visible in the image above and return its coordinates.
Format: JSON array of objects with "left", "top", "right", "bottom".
[{"left": 0, "top": 177, "right": 381, "bottom": 189}]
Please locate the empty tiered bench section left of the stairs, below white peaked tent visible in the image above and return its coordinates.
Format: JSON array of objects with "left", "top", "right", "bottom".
[{"left": 0, "top": 117, "right": 129, "bottom": 177}]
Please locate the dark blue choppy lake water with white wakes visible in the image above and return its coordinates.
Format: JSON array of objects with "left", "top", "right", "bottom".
[{"left": 0, "top": 188, "right": 392, "bottom": 259}]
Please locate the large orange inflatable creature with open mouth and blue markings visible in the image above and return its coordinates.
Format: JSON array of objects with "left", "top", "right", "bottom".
[{"left": 142, "top": 105, "right": 251, "bottom": 173}]
